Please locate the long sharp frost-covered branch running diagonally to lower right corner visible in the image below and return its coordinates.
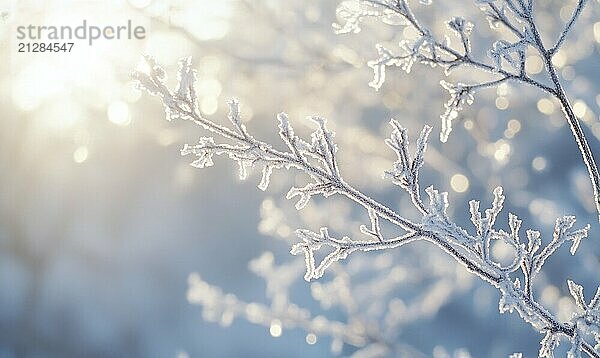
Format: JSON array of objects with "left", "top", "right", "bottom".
[{"left": 134, "top": 52, "right": 600, "bottom": 358}]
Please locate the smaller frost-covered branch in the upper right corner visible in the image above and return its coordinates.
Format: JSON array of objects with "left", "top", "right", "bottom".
[{"left": 346, "top": 0, "right": 600, "bottom": 222}]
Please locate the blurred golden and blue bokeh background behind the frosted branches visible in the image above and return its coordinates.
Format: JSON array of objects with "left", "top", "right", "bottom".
[{"left": 0, "top": 0, "right": 600, "bottom": 357}]
